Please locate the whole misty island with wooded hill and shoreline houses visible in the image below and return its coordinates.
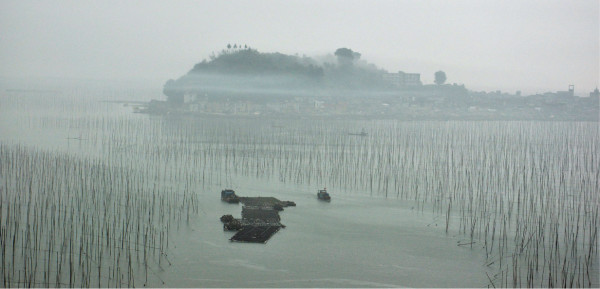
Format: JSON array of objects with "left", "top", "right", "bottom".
[{"left": 143, "top": 45, "right": 600, "bottom": 121}]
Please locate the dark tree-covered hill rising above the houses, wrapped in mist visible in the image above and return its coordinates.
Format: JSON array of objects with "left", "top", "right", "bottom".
[{"left": 163, "top": 45, "right": 390, "bottom": 101}]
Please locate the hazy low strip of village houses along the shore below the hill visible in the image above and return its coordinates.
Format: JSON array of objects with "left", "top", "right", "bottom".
[{"left": 138, "top": 71, "right": 600, "bottom": 121}]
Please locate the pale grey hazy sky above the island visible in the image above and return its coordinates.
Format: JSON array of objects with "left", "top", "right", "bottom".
[{"left": 0, "top": 0, "right": 600, "bottom": 96}]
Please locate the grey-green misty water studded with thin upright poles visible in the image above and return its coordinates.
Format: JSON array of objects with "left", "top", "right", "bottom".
[{"left": 0, "top": 85, "right": 600, "bottom": 287}]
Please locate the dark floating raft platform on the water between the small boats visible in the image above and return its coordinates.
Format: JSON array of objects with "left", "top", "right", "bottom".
[{"left": 223, "top": 197, "right": 296, "bottom": 243}]
